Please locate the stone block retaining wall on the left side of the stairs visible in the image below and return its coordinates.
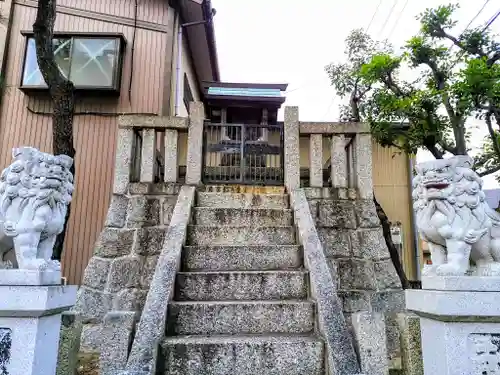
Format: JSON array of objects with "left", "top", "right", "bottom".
[{"left": 73, "top": 183, "right": 180, "bottom": 352}]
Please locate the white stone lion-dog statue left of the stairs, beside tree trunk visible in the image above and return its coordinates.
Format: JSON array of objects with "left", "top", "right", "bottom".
[{"left": 0, "top": 147, "right": 73, "bottom": 271}]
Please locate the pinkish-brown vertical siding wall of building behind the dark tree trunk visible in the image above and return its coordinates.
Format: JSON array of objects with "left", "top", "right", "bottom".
[{"left": 0, "top": 0, "right": 170, "bottom": 284}]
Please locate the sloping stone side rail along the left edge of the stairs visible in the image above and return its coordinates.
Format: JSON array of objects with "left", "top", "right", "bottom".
[{"left": 126, "top": 185, "right": 195, "bottom": 375}]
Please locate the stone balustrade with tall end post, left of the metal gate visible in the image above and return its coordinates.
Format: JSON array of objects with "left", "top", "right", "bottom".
[{"left": 113, "top": 102, "right": 204, "bottom": 194}]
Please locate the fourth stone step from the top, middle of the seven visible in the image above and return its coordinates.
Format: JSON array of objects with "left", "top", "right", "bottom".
[{"left": 182, "top": 245, "right": 303, "bottom": 271}]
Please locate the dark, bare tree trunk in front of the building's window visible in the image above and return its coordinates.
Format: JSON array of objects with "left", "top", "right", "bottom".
[{"left": 33, "top": 0, "right": 75, "bottom": 260}]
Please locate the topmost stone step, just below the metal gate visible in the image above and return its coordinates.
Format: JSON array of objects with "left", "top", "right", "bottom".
[{"left": 196, "top": 192, "right": 289, "bottom": 208}]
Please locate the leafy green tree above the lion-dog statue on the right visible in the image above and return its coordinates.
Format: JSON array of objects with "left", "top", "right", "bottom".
[{"left": 354, "top": 5, "right": 500, "bottom": 175}]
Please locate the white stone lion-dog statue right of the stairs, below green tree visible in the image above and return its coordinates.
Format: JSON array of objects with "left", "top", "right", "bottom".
[{"left": 413, "top": 156, "right": 500, "bottom": 276}]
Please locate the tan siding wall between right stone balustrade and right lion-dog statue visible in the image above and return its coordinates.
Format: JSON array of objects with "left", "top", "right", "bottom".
[{"left": 373, "top": 143, "right": 416, "bottom": 280}]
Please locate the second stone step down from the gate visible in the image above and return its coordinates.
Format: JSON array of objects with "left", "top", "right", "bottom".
[{"left": 194, "top": 207, "right": 292, "bottom": 227}]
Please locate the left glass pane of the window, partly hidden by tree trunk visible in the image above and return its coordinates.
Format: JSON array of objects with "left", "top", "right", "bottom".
[{"left": 23, "top": 38, "right": 71, "bottom": 86}]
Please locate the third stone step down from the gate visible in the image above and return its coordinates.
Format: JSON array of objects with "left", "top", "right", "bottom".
[{"left": 187, "top": 225, "right": 296, "bottom": 246}]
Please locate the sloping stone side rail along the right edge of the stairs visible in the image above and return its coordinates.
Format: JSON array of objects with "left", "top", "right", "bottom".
[{"left": 290, "top": 189, "right": 360, "bottom": 375}]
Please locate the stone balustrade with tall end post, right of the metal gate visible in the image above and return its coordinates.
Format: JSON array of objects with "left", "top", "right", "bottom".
[{"left": 284, "top": 107, "right": 373, "bottom": 199}]
